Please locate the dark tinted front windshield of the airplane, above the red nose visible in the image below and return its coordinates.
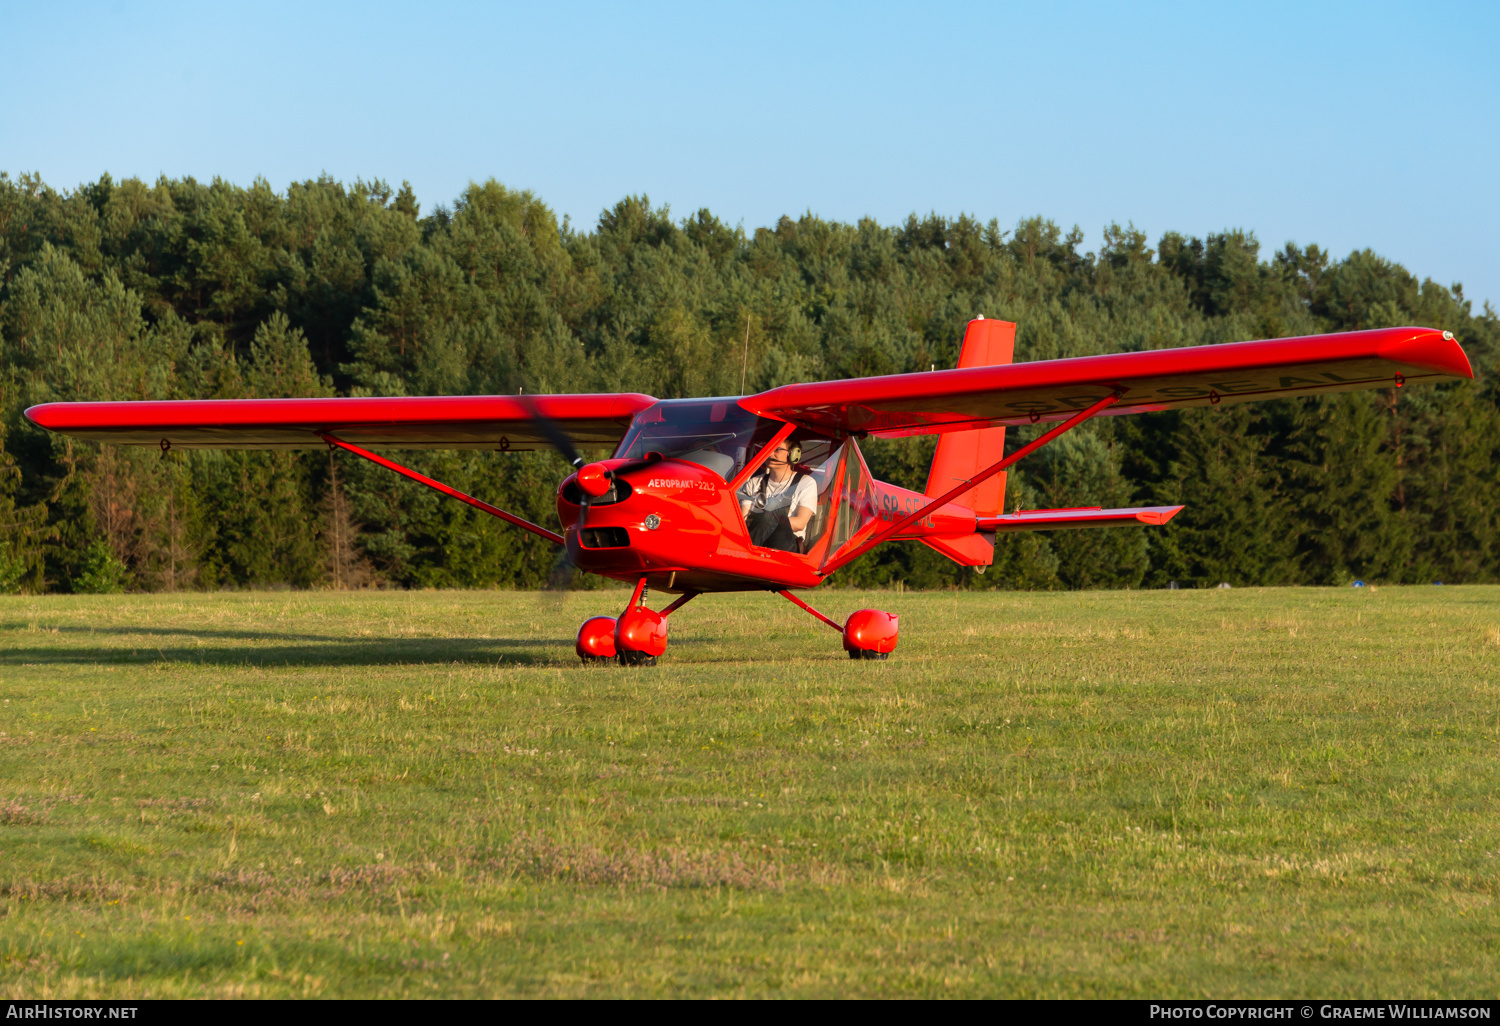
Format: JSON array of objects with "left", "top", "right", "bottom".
[{"left": 615, "top": 399, "right": 782, "bottom": 482}]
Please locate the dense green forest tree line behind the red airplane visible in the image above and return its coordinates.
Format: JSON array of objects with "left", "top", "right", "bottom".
[{"left": 0, "top": 174, "right": 1500, "bottom": 593}]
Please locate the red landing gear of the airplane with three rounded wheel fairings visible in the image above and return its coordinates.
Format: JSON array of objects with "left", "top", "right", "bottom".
[{"left": 575, "top": 578, "right": 900, "bottom": 666}]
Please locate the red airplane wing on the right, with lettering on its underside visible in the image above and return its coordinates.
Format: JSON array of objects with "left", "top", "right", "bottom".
[{"left": 741, "top": 327, "right": 1475, "bottom": 438}]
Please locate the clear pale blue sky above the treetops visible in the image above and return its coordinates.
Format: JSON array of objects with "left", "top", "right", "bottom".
[{"left": 0, "top": 0, "right": 1500, "bottom": 309}]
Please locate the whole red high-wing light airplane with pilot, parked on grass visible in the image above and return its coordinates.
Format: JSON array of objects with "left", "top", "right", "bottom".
[{"left": 26, "top": 317, "right": 1473, "bottom": 665}]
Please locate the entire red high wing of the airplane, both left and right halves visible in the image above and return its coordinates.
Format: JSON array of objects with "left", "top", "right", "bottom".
[{"left": 26, "top": 327, "right": 1473, "bottom": 450}]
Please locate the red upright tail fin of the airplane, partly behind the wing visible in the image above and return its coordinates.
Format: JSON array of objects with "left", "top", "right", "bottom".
[{"left": 923, "top": 317, "right": 1016, "bottom": 567}]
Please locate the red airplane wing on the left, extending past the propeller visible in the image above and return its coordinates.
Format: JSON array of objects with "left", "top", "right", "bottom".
[{"left": 26, "top": 392, "right": 656, "bottom": 450}]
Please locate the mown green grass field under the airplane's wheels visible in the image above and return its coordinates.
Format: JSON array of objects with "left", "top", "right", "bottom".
[{"left": 0, "top": 587, "right": 1500, "bottom": 998}]
